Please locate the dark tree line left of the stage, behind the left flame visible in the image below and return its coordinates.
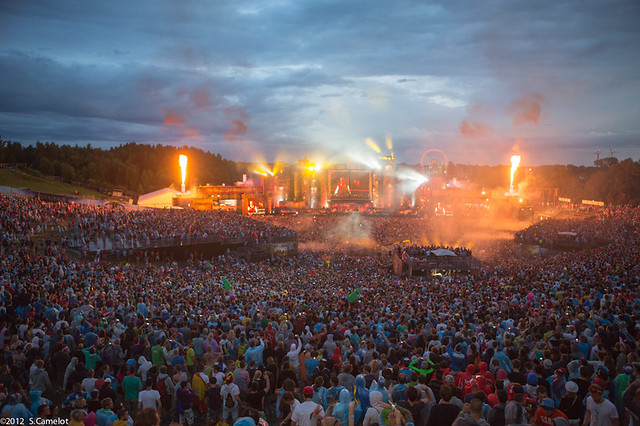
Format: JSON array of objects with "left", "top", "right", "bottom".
[{"left": 0, "top": 140, "right": 242, "bottom": 194}]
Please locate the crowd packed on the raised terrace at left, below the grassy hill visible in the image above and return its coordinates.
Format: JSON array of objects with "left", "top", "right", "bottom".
[{"left": 4, "top": 197, "right": 295, "bottom": 251}]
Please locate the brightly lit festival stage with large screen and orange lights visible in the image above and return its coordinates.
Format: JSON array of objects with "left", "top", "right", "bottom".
[{"left": 158, "top": 149, "right": 458, "bottom": 215}]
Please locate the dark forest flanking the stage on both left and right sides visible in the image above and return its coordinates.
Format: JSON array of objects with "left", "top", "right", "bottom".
[{"left": 0, "top": 139, "right": 640, "bottom": 206}]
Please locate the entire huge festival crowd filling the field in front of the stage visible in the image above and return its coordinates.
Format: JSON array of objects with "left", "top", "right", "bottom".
[{"left": 0, "top": 196, "right": 640, "bottom": 426}]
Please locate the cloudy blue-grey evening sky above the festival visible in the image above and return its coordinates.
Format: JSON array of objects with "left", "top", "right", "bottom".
[{"left": 0, "top": 0, "right": 640, "bottom": 165}]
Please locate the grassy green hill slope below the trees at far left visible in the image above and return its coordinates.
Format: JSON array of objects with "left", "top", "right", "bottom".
[{"left": 0, "top": 169, "right": 109, "bottom": 199}]
